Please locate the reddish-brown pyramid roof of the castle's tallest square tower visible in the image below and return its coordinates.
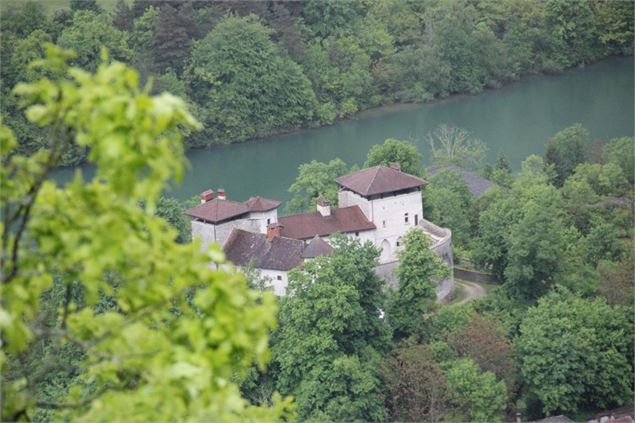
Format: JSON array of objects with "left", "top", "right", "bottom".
[{"left": 335, "top": 166, "right": 428, "bottom": 197}]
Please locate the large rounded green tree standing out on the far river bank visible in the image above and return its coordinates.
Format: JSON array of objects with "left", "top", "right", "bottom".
[{"left": 188, "top": 16, "right": 315, "bottom": 144}]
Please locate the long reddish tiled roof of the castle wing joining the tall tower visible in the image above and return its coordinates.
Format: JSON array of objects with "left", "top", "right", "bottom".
[{"left": 278, "top": 206, "right": 376, "bottom": 239}]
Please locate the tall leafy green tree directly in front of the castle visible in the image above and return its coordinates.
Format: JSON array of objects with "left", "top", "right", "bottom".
[{"left": 273, "top": 237, "right": 390, "bottom": 421}]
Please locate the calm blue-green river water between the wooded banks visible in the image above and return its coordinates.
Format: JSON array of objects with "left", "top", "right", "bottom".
[{"left": 54, "top": 57, "right": 635, "bottom": 201}]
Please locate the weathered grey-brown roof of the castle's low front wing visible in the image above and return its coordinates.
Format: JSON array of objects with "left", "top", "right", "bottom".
[{"left": 223, "top": 229, "right": 304, "bottom": 271}]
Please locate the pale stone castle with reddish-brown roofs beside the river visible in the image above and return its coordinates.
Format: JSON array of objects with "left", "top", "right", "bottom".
[{"left": 185, "top": 165, "right": 454, "bottom": 301}]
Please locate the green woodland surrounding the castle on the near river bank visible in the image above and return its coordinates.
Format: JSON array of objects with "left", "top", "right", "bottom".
[{"left": 217, "top": 124, "right": 635, "bottom": 421}]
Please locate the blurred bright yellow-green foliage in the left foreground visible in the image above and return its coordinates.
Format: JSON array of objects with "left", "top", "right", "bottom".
[{"left": 0, "top": 44, "right": 288, "bottom": 421}]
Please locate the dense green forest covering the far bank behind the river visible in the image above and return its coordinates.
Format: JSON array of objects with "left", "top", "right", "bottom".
[{"left": 0, "top": 0, "right": 634, "bottom": 165}]
